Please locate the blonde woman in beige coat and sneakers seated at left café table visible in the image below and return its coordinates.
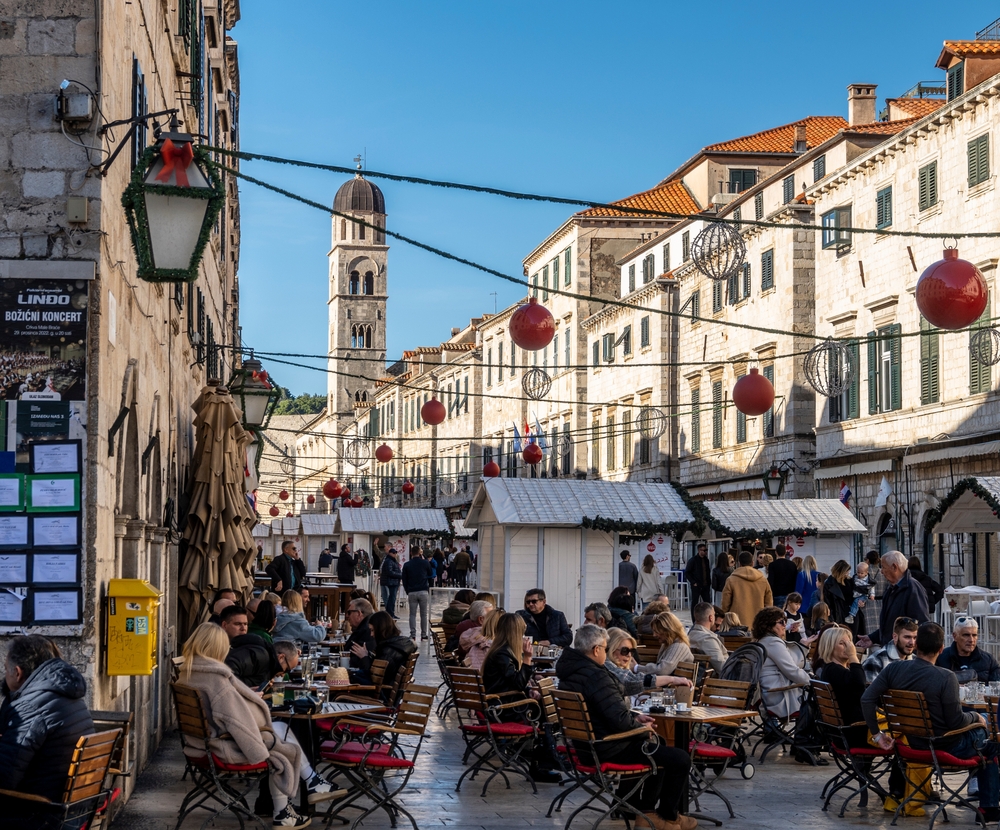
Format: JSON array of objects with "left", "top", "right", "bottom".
[{"left": 180, "top": 623, "right": 343, "bottom": 828}]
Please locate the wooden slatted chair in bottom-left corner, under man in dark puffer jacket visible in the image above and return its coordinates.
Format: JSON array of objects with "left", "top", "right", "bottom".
[{"left": 0, "top": 729, "right": 122, "bottom": 830}]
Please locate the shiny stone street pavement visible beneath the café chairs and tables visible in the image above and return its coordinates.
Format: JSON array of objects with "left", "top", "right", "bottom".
[{"left": 107, "top": 596, "right": 974, "bottom": 830}]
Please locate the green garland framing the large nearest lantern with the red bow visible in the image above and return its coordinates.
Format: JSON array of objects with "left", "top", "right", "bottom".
[{"left": 122, "top": 145, "right": 226, "bottom": 282}]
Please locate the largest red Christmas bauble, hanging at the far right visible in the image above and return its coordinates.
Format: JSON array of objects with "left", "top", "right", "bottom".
[{"left": 917, "top": 248, "right": 989, "bottom": 331}]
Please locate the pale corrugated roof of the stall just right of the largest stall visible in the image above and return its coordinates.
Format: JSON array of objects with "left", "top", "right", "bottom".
[{"left": 702, "top": 499, "right": 868, "bottom": 535}]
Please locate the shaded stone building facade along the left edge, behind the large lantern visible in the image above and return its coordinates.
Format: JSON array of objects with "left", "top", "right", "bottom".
[{"left": 0, "top": 0, "right": 240, "bottom": 788}]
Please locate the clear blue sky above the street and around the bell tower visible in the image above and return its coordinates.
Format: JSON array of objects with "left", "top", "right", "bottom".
[{"left": 231, "top": 0, "right": 998, "bottom": 394}]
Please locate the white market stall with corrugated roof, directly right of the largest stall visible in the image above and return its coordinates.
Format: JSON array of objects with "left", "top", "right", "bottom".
[{"left": 701, "top": 499, "right": 868, "bottom": 573}]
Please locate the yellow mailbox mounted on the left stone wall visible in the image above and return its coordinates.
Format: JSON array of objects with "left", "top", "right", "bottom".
[{"left": 107, "top": 579, "right": 160, "bottom": 675}]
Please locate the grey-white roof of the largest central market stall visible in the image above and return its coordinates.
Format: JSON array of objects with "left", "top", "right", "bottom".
[{"left": 465, "top": 478, "right": 694, "bottom": 527}]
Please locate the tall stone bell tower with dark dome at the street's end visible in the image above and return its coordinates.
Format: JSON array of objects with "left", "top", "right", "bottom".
[{"left": 327, "top": 156, "right": 389, "bottom": 434}]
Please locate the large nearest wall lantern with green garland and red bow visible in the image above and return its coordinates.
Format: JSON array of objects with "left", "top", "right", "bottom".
[{"left": 122, "top": 132, "right": 226, "bottom": 282}]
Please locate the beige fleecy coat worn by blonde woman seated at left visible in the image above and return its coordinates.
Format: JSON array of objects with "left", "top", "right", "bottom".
[{"left": 180, "top": 657, "right": 302, "bottom": 799}]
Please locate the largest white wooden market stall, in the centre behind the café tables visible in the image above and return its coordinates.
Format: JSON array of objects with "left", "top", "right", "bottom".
[{"left": 465, "top": 478, "right": 693, "bottom": 626}]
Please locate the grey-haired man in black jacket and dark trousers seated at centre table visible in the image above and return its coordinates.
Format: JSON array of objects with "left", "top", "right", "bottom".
[{"left": 556, "top": 615, "right": 698, "bottom": 830}]
